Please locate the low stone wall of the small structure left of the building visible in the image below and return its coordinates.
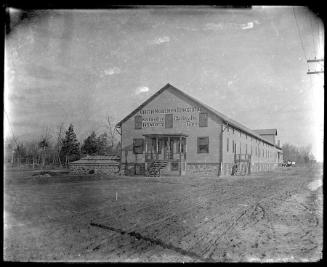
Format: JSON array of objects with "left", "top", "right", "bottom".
[{"left": 69, "top": 164, "right": 119, "bottom": 175}]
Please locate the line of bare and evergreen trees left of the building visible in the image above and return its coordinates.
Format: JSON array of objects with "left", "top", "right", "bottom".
[{"left": 5, "top": 117, "right": 120, "bottom": 168}]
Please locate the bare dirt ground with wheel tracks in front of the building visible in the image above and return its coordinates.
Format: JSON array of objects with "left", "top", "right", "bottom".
[{"left": 4, "top": 166, "right": 323, "bottom": 262}]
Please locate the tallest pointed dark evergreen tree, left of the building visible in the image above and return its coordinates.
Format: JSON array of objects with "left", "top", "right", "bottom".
[{"left": 61, "top": 124, "right": 80, "bottom": 166}]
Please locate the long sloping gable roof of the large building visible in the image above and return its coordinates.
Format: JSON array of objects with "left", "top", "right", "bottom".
[{"left": 116, "top": 83, "right": 280, "bottom": 149}]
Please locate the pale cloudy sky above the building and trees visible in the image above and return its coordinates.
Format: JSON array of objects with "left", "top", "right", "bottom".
[{"left": 4, "top": 6, "right": 324, "bottom": 161}]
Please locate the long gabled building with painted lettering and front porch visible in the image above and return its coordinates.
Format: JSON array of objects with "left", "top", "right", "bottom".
[{"left": 116, "top": 84, "right": 282, "bottom": 176}]
